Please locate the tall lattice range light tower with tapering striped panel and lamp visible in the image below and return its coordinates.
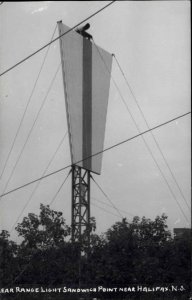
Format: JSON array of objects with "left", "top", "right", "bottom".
[{"left": 58, "top": 21, "right": 112, "bottom": 244}]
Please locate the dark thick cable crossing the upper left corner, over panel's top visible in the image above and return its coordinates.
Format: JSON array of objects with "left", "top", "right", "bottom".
[{"left": 0, "top": 0, "right": 116, "bottom": 77}]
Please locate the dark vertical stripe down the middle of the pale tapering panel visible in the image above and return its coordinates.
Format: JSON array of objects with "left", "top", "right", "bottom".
[{"left": 83, "top": 38, "right": 92, "bottom": 170}]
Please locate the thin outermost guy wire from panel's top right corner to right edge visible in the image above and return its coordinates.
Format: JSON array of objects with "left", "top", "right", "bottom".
[{"left": 112, "top": 54, "right": 190, "bottom": 209}]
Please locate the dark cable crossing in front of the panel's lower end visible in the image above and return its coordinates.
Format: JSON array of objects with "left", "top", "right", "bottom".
[{"left": 0, "top": 112, "right": 191, "bottom": 200}]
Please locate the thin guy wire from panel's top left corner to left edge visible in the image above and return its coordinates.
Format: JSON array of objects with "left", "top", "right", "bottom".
[{"left": 0, "top": 26, "right": 57, "bottom": 179}]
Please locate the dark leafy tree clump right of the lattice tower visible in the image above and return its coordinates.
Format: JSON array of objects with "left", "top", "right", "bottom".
[{"left": 87, "top": 214, "right": 191, "bottom": 285}]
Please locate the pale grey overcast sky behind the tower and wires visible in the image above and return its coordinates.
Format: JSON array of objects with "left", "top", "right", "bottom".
[{"left": 0, "top": 1, "right": 191, "bottom": 241}]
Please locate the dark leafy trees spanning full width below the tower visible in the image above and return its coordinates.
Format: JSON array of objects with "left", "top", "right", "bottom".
[{"left": 0, "top": 204, "right": 191, "bottom": 299}]
